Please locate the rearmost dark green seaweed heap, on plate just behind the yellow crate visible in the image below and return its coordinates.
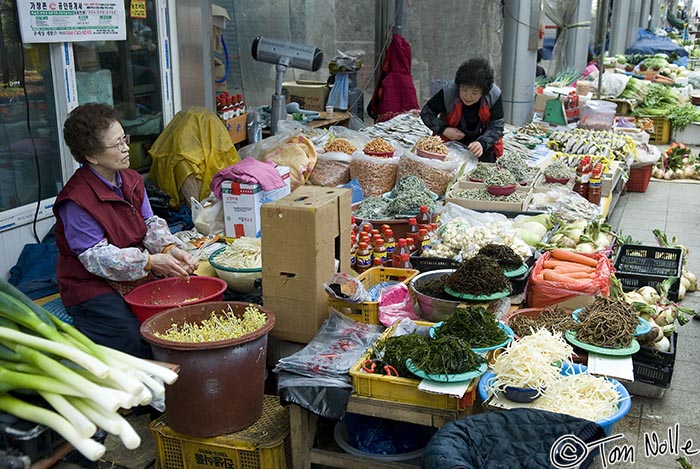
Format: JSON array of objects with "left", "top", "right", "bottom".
[{"left": 435, "top": 304, "right": 507, "bottom": 348}]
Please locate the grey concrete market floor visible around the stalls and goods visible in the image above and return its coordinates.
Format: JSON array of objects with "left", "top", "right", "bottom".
[{"left": 56, "top": 181, "right": 700, "bottom": 469}]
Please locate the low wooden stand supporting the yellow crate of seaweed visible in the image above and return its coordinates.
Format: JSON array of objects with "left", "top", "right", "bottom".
[{"left": 289, "top": 379, "right": 478, "bottom": 469}]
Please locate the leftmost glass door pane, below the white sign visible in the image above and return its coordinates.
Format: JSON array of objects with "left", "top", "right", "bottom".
[{"left": 0, "top": 0, "right": 63, "bottom": 212}]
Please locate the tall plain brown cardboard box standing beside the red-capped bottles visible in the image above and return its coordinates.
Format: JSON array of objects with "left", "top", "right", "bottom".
[{"left": 260, "top": 186, "right": 351, "bottom": 343}]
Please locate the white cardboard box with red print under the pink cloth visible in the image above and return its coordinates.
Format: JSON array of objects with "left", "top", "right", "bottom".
[{"left": 221, "top": 166, "right": 290, "bottom": 238}]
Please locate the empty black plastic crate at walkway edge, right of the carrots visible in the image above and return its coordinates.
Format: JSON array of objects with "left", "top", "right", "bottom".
[{"left": 614, "top": 244, "right": 683, "bottom": 301}]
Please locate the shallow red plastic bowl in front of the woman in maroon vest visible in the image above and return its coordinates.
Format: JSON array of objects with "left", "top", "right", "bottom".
[{"left": 124, "top": 276, "right": 227, "bottom": 322}]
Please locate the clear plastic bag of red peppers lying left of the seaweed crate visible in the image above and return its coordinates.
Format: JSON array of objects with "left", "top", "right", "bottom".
[{"left": 273, "top": 311, "right": 384, "bottom": 378}]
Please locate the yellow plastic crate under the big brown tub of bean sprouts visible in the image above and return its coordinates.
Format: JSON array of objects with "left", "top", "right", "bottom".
[{"left": 149, "top": 396, "right": 292, "bottom": 469}]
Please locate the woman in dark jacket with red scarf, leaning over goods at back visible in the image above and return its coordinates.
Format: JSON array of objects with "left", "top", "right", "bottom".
[{"left": 421, "top": 58, "right": 505, "bottom": 162}]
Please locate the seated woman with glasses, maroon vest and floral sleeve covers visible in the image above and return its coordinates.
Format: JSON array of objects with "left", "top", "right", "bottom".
[{"left": 53, "top": 103, "right": 197, "bottom": 357}]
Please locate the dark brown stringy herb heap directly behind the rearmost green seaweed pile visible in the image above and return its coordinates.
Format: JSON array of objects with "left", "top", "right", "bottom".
[{"left": 446, "top": 254, "right": 510, "bottom": 295}]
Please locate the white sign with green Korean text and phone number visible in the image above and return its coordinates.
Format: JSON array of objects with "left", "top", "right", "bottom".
[{"left": 17, "top": 0, "right": 126, "bottom": 43}]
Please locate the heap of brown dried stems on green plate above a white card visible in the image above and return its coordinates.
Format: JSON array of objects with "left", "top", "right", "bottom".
[{"left": 576, "top": 297, "right": 639, "bottom": 348}]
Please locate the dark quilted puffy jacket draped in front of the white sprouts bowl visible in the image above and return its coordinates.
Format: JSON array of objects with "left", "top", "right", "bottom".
[{"left": 423, "top": 409, "right": 605, "bottom": 469}]
